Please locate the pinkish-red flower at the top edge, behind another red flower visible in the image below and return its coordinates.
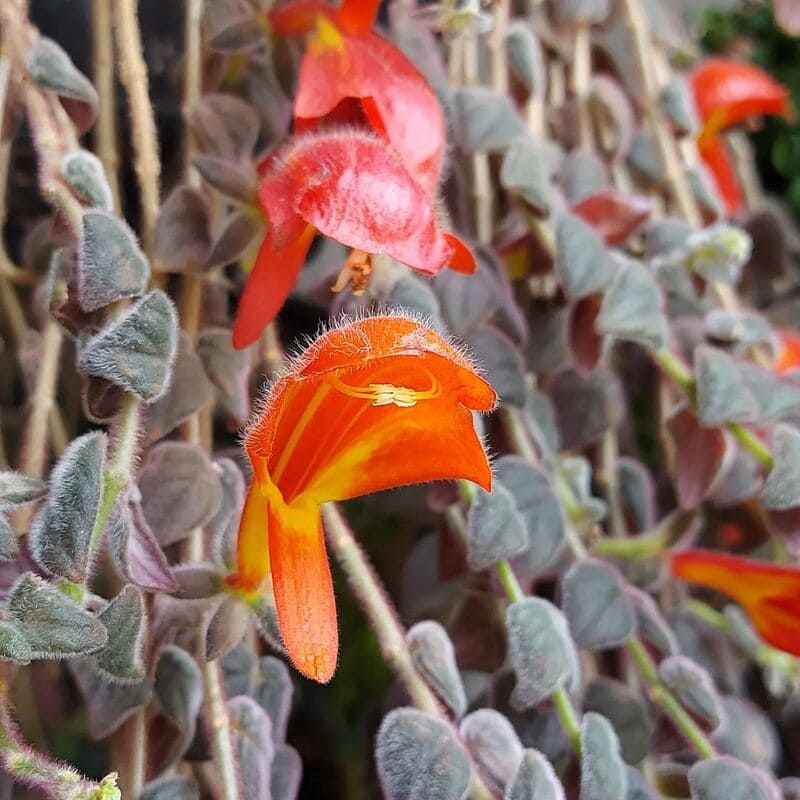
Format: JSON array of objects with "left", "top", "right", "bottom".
[{"left": 269, "top": 0, "right": 445, "bottom": 197}]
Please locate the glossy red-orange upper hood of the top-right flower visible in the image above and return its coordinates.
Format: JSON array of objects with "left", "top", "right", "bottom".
[{"left": 689, "top": 58, "right": 789, "bottom": 135}]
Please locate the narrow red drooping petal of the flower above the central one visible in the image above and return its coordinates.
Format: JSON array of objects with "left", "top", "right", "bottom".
[{"left": 233, "top": 225, "right": 314, "bottom": 349}]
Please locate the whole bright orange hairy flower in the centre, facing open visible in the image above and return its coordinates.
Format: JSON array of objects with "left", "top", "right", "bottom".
[{"left": 228, "top": 316, "right": 496, "bottom": 683}]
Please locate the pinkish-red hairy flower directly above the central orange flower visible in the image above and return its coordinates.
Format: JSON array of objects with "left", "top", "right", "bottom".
[{"left": 233, "top": 131, "right": 475, "bottom": 348}]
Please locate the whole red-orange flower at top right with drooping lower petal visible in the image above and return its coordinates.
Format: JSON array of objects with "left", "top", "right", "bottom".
[{"left": 689, "top": 58, "right": 789, "bottom": 214}]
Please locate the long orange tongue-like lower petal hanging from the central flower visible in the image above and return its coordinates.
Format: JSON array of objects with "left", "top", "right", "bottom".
[{"left": 268, "top": 493, "right": 339, "bottom": 683}]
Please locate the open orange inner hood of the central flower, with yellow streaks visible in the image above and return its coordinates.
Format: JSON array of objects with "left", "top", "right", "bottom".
[{"left": 262, "top": 354, "right": 494, "bottom": 503}]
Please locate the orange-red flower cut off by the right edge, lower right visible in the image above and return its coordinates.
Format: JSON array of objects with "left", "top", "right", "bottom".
[{"left": 672, "top": 550, "right": 800, "bottom": 656}]
